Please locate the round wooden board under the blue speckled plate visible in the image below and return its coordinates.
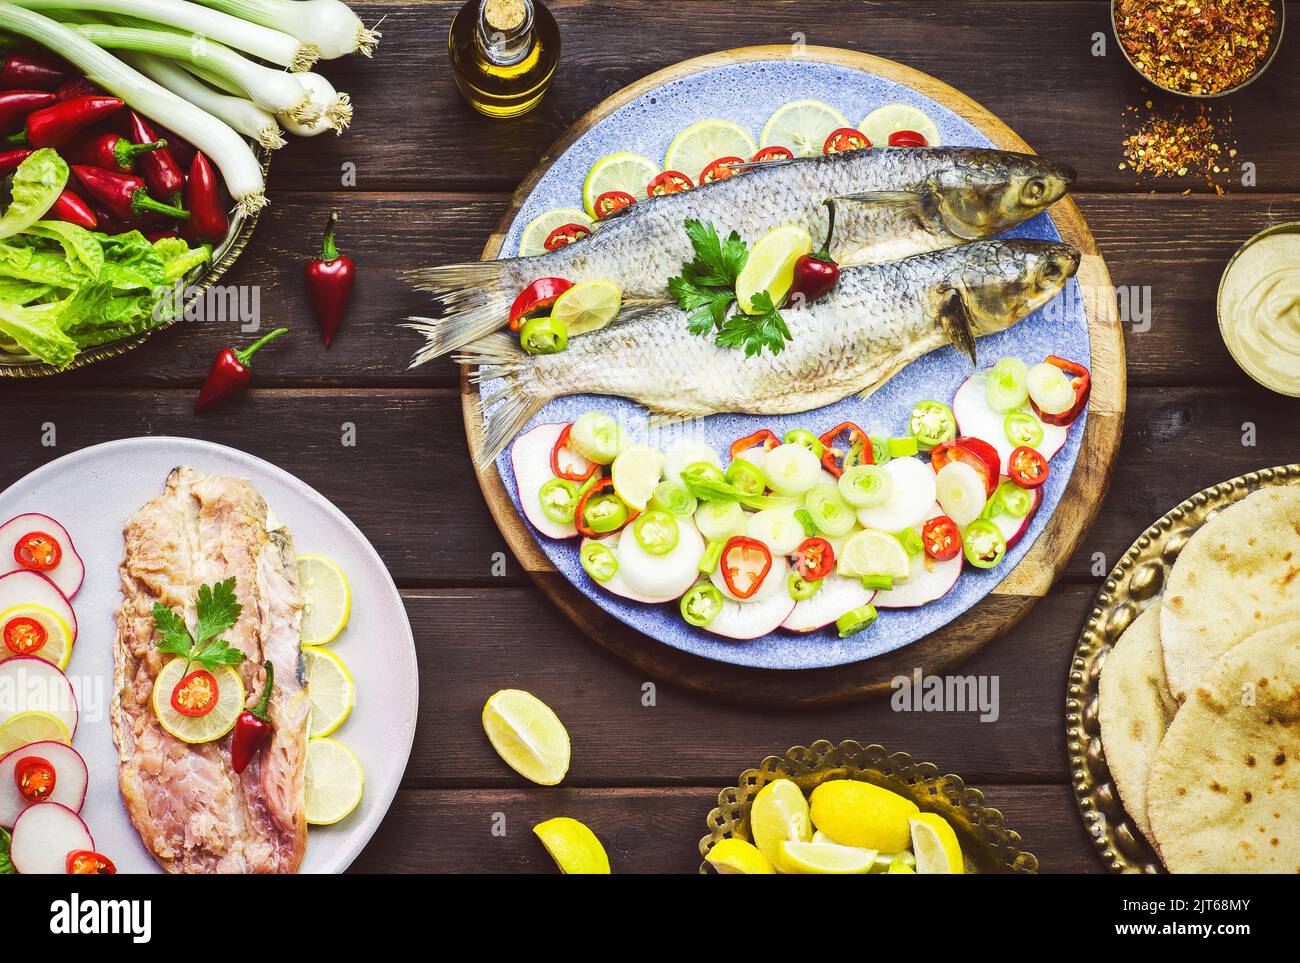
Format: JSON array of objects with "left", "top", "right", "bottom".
[{"left": 460, "top": 45, "right": 1126, "bottom": 707}]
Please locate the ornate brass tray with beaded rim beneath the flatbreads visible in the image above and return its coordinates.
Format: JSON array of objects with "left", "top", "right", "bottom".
[{"left": 1065, "top": 464, "right": 1300, "bottom": 873}]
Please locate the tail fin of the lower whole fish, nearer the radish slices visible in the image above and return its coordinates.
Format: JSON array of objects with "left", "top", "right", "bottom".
[{"left": 452, "top": 334, "right": 554, "bottom": 468}]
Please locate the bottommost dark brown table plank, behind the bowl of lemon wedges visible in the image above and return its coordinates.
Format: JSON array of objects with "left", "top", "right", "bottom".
[{"left": 351, "top": 784, "right": 1101, "bottom": 873}]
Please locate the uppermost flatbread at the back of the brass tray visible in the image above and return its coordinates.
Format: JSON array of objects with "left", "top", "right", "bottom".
[{"left": 1160, "top": 485, "right": 1300, "bottom": 702}]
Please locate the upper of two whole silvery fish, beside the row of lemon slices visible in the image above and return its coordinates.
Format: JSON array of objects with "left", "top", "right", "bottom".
[{"left": 406, "top": 147, "right": 1075, "bottom": 365}]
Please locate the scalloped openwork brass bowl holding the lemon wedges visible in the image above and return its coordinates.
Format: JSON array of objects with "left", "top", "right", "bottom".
[{"left": 699, "top": 739, "right": 1039, "bottom": 873}]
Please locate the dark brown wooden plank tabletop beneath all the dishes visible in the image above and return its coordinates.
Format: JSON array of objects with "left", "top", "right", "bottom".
[{"left": 0, "top": 0, "right": 1300, "bottom": 872}]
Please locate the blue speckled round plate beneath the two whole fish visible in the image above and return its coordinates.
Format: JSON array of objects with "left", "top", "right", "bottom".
[{"left": 478, "top": 60, "right": 1091, "bottom": 669}]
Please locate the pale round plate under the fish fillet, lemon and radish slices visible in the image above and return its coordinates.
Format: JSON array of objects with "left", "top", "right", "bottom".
[{"left": 0, "top": 437, "right": 419, "bottom": 873}]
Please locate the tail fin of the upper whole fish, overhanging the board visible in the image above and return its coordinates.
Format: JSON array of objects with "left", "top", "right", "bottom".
[{"left": 402, "top": 261, "right": 512, "bottom": 368}]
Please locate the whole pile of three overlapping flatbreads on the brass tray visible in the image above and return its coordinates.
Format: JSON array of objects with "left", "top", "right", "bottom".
[{"left": 1099, "top": 486, "right": 1300, "bottom": 873}]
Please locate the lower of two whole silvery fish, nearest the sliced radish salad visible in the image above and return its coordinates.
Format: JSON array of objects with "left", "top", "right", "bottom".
[{"left": 456, "top": 238, "right": 1079, "bottom": 464}]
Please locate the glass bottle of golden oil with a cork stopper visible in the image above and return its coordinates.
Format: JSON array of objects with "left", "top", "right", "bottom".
[{"left": 447, "top": 0, "right": 560, "bottom": 117}]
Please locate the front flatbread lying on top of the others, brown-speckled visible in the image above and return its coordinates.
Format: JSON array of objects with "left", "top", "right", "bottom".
[{"left": 1147, "top": 621, "right": 1300, "bottom": 873}]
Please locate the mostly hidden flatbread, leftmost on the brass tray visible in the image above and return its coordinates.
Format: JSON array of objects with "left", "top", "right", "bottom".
[{"left": 1097, "top": 603, "right": 1178, "bottom": 840}]
